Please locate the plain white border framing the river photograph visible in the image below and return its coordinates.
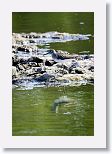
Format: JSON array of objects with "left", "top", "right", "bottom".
[{"left": 0, "top": 0, "right": 106, "bottom": 148}]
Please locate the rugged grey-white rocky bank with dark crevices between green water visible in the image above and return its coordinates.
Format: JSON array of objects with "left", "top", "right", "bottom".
[{"left": 12, "top": 32, "right": 94, "bottom": 87}]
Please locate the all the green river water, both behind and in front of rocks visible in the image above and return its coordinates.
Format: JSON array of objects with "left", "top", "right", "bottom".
[{"left": 12, "top": 12, "right": 94, "bottom": 136}]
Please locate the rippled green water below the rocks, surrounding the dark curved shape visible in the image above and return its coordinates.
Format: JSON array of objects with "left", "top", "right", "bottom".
[{"left": 12, "top": 85, "right": 94, "bottom": 136}]
